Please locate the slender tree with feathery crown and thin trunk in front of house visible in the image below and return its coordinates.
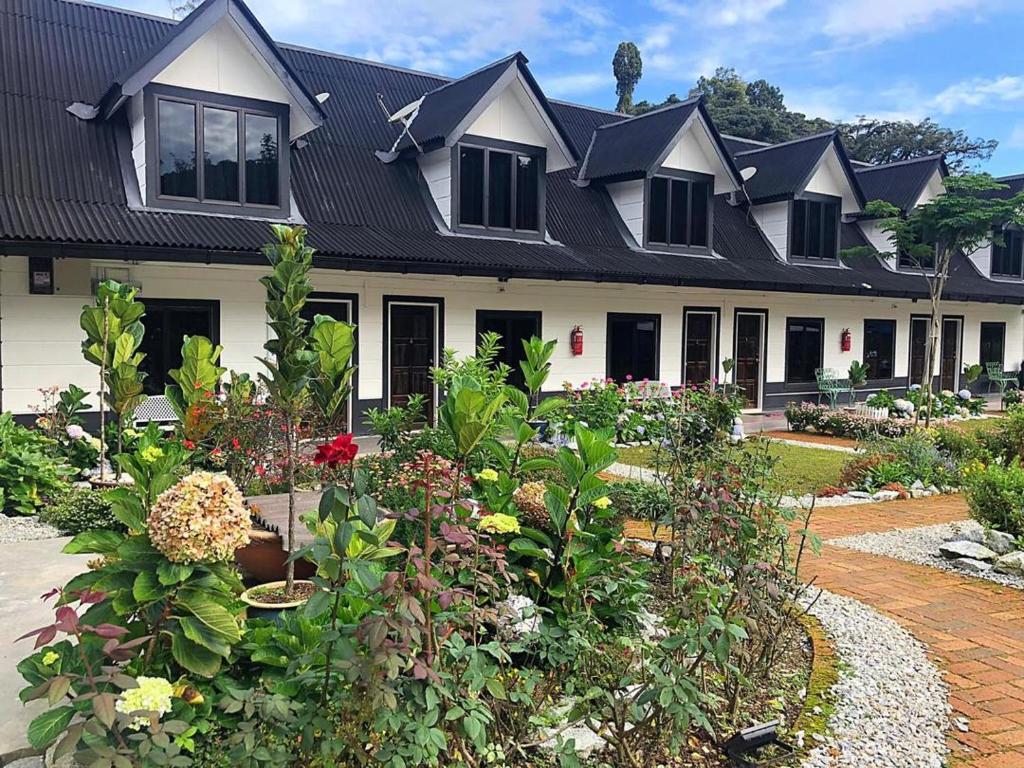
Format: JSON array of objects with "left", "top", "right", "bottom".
[{"left": 843, "top": 173, "right": 1024, "bottom": 425}]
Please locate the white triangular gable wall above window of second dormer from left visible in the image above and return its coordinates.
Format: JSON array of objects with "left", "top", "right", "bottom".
[{"left": 464, "top": 74, "right": 572, "bottom": 173}]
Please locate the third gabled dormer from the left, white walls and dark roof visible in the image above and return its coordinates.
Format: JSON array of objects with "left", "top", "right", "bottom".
[{"left": 578, "top": 97, "right": 741, "bottom": 255}]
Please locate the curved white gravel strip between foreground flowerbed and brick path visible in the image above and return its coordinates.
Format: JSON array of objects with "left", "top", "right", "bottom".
[{"left": 802, "top": 591, "right": 949, "bottom": 768}]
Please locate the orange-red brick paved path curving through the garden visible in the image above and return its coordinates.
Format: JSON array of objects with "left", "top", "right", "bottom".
[{"left": 629, "top": 496, "right": 1024, "bottom": 768}]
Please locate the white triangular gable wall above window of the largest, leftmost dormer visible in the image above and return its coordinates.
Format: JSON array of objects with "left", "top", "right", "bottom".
[{"left": 153, "top": 17, "right": 315, "bottom": 139}]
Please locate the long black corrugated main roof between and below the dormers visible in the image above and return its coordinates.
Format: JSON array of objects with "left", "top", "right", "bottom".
[{"left": 0, "top": 0, "right": 1024, "bottom": 303}]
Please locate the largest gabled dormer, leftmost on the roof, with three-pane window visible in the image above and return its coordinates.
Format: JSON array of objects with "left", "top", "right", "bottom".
[{"left": 69, "top": 0, "right": 325, "bottom": 218}]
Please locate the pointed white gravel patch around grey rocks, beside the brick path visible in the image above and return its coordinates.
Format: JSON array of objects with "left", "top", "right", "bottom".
[{"left": 828, "top": 520, "right": 1024, "bottom": 589}]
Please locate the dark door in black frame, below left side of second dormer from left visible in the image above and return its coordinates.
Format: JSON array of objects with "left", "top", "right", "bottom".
[{"left": 388, "top": 304, "right": 437, "bottom": 422}]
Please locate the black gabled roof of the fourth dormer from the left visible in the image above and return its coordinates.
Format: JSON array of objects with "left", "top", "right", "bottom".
[{"left": 733, "top": 130, "right": 864, "bottom": 206}]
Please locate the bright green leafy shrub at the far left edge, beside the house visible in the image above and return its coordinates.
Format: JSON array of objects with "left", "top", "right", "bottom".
[{"left": 0, "top": 413, "right": 75, "bottom": 515}]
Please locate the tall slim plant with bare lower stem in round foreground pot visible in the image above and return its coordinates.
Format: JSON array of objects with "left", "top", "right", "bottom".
[{"left": 259, "top": 224, "right": 317, "bottom": 594}]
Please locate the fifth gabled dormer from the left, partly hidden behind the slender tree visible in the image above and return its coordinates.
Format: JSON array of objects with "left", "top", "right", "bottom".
[{"left": 857, "top": 155, "right": 949, "bottom": 272}]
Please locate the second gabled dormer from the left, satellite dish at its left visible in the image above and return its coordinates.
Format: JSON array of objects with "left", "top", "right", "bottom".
[{"left": 378, "top": 53, "right": 577, "bottom": 240}]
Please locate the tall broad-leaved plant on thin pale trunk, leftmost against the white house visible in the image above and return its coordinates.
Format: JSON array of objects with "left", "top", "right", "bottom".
[{"left": 80, "top": 280, "right": 145, "bottom": 479}]
